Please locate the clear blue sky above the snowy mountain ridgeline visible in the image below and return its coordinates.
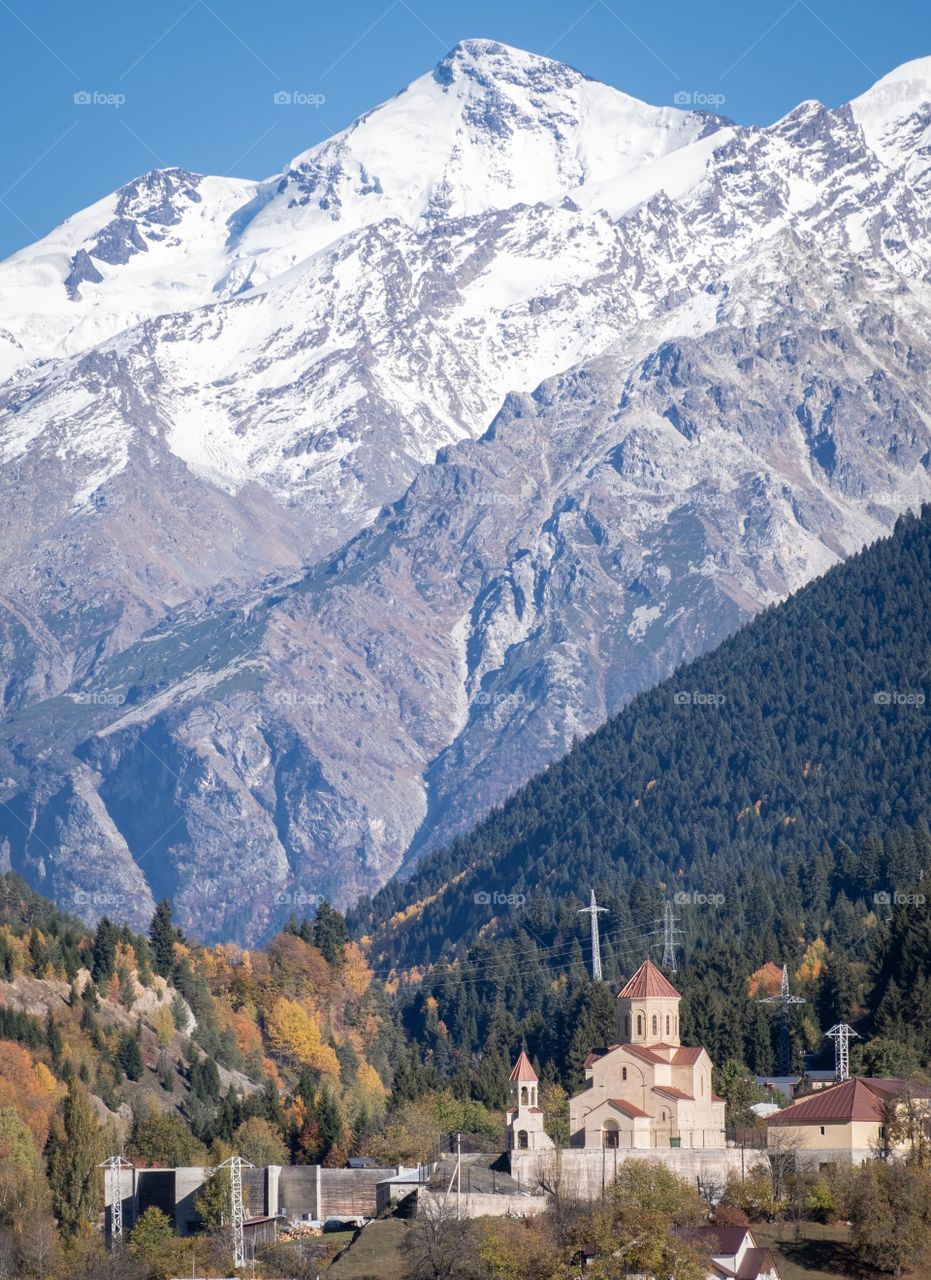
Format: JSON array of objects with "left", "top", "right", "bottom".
[{"left": 0, "top": 0, "right": 931, "bottom": 256}]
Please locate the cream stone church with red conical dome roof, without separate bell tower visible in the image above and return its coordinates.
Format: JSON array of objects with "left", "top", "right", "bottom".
[{"left": 569, "top": 960, "right": 725, "bottom": 1149}]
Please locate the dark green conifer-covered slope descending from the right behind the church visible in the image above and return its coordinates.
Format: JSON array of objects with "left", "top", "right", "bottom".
[{"left": 352, "top": 509, "right": 931, "bottom": 1080}]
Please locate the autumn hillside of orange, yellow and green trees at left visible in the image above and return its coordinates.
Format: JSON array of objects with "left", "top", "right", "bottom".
[{"left": 0, "top": 874, "right": 412, "bottom": 1276}]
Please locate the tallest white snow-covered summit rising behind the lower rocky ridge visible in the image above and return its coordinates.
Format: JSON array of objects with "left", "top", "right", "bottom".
[{"left": 237, "top": 40, "right": 726, "bottom": 284}]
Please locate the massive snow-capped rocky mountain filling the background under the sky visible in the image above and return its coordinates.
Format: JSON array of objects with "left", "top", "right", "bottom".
[{"left": 0, "top": 41, "right": 931, "bottom": 938}]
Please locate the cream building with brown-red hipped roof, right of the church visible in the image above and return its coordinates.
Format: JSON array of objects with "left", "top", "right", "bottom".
[{"left": 766, "top": 1076, "right": 931, "bottom": 1164}]
